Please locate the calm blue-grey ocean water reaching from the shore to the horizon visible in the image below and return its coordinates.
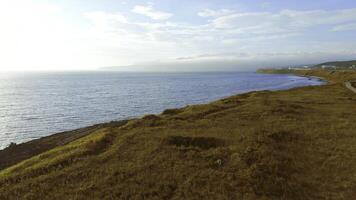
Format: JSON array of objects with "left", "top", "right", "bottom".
[{"left": 0, "top": 72, "right": 321, "bottom": 149}]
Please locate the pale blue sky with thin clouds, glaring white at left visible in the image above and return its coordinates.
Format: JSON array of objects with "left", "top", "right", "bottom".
[{"left": 0, "top": 0, "right": 356, "bottom": 71}]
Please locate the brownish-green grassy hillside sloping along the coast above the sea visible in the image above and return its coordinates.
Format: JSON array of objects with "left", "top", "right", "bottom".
[{"left": 0, "top": 71, "right": 356, "bottom": 199}]
